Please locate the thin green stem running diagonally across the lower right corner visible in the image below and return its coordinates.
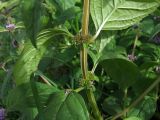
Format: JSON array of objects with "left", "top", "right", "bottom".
[{"left": 112, "top": 77, "right": 160, "bottom": 120}]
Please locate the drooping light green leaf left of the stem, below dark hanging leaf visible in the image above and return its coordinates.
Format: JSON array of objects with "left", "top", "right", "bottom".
[{"left": 13, "top": 39, "right": 46, "bottom": 85}]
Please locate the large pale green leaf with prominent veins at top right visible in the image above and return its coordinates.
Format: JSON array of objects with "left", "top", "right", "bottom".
[{"left": 90, "top": 0, "right": 159, "bottom": 37}]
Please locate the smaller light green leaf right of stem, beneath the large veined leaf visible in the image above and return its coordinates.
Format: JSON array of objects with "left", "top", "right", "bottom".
[{"left": 88, "top": 31, "right": 127, "bottom": 66}]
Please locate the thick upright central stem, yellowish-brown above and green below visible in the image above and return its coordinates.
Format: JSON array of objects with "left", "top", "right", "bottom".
[{"left": 80, "top": 0, "right": 102, "bottom": 120}]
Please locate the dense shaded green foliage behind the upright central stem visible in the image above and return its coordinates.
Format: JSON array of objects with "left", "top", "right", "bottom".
[{"left": 0, "top": 0, "right": 160, "bottom": 120}]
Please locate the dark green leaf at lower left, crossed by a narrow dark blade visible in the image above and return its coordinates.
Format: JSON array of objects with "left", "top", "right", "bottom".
[{"left": 6, "top": 83, "right": 59, "bottom": 112}]
